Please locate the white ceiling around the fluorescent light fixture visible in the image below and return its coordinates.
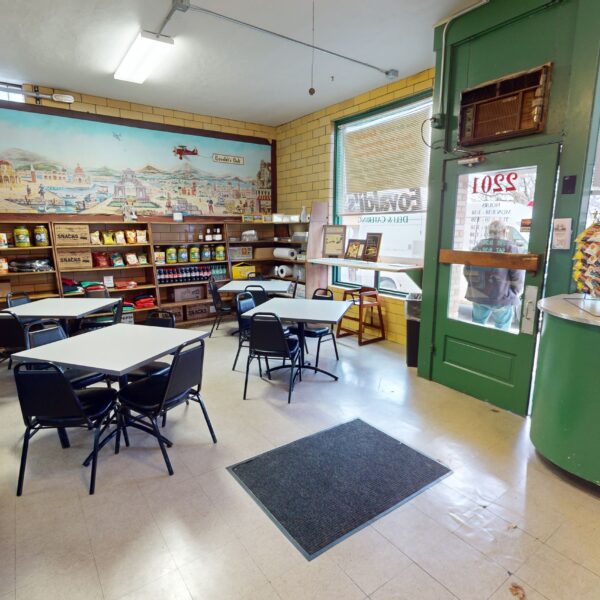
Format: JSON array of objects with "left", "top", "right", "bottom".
[{"left": 0, "top": 0, "right": 474, "bottom": 125}]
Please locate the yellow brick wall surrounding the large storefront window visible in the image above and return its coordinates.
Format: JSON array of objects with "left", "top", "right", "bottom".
[{"left": 276, "top": 69, "right": 434, "bottom": 346}]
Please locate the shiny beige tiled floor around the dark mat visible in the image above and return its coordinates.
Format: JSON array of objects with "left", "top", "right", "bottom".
[{"left": 0, "top": 326, "right": 600, "bottom": 600}]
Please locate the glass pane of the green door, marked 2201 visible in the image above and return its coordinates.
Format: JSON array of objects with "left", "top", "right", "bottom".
[{"left": 448, "top": 166, "right": 537, "bottom": 334}]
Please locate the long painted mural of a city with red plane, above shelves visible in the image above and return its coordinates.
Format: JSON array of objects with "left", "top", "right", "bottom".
[{"left": 0, "top": 108, "right": 272, "bottom": 216}]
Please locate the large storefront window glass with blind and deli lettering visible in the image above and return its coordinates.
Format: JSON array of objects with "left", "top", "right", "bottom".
[{"left": 335, "top": 98, "right": 431, "bottom": 293}]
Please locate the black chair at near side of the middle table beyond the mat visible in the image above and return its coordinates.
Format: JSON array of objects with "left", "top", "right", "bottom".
[{"left": 244, "top": 312, "right": 302, "bottom": 404}]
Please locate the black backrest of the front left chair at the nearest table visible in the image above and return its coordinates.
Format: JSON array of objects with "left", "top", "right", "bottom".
[{"left": 14, "top": 363, "right": 91, "bottom": 426}]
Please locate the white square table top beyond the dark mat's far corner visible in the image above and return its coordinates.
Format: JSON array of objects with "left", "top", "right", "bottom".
[{"left": 242, "top": 298, "right": 352, "bottom": 323}]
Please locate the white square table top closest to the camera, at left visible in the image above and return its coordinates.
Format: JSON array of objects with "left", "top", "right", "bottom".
[{"left": 12, "top": 323, "right": 208, "bottom": 377}]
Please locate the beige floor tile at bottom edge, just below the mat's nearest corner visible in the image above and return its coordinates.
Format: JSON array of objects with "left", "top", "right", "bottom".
[{"left": 271, "top": 555, "right": 366, "bottom": 600}]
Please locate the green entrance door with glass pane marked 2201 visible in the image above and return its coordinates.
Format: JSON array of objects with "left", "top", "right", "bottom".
[{"left": 432, "top": 144, "right": 559, "bottom": 415}]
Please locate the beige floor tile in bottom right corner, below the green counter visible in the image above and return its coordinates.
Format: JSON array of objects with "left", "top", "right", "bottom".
[{"left": 516, "top": 546, "right": 600, "bottom": 600}]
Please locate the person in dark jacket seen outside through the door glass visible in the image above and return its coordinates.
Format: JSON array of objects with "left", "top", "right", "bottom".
[{"left": 463, "top": 220, "right": 525, "bottom": 331}]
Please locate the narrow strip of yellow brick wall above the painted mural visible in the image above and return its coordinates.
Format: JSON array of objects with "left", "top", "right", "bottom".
[{"left": 23, "top": 85, "right": 276, "bottom": 140}]
